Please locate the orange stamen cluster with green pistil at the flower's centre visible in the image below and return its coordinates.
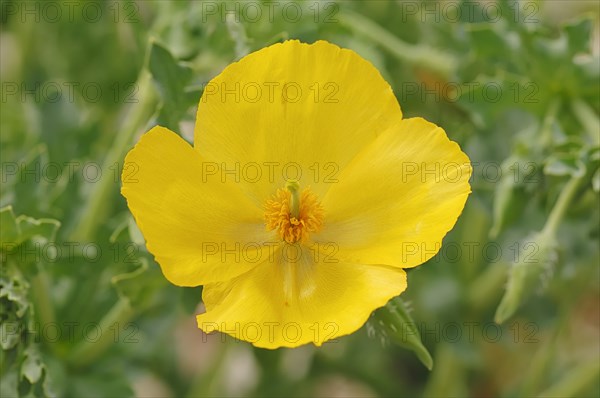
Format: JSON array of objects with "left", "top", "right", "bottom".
[{"left": 265, "top": 181, "right": 323, "bottom": 243}]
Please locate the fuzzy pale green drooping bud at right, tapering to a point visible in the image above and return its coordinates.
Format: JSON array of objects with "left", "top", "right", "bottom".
[{"left": 494, "top": 232, "right": 558, "bottom": 324}]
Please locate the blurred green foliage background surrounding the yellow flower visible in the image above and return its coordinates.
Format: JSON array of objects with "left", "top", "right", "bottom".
[{"left": 0, "top": 0, "right": 600, "bottom": 397}]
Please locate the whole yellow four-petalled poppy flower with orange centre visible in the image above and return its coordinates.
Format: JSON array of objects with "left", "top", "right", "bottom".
[{"left": 122, "top": 41, "right": 471, "bottom": 348}]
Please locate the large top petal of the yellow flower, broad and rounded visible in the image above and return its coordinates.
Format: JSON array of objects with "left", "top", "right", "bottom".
[{"left": 194, "top": 40, "right": 402, "bottom": 205}]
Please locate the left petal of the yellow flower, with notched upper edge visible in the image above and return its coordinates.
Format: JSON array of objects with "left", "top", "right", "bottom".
[{"left": 121, "top": 127, "right": 271, "bottom": 286}]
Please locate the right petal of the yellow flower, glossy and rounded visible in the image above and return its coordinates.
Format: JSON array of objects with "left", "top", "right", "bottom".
[{"left": 314, "top": 118, "right": 472, "bottom": 268}]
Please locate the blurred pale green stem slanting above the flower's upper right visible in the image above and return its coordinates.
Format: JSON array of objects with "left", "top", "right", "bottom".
[{"left": 339, "top": 10, "right": 458, "bottom": 77}]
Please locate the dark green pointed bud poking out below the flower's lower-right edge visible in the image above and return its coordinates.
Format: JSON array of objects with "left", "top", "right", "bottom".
[{"left": 371, "top": 297, "right": 433, "bottom": 370}]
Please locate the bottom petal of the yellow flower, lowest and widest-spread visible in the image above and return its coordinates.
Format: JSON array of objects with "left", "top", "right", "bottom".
[{"left": 197, "top": 244, "right": 406, "bottom": 348}]
